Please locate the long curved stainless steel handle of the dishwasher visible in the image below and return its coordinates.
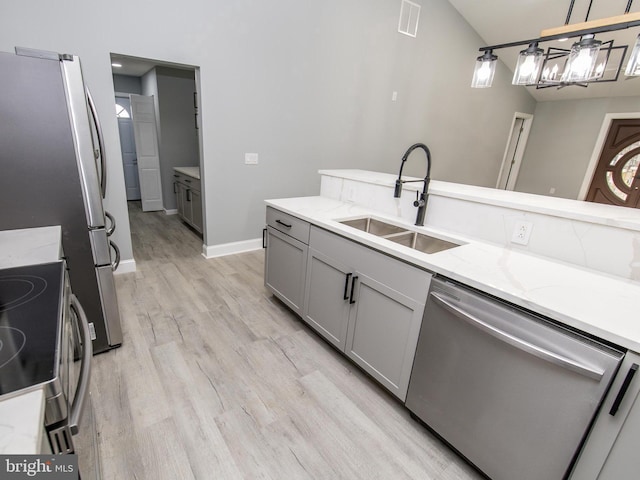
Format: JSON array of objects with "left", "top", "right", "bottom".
[{"left": 431, "top": 292, "right": 604, "bottom": 381}]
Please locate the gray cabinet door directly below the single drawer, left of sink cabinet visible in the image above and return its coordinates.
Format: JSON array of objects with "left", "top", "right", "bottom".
[{"left": 265, "top": 227, "right": 309, "bottom": 316}]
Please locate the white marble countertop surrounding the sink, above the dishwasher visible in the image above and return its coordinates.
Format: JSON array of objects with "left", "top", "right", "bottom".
[{"left": 266, "top": 197, "right": 640, "bottom": 352}]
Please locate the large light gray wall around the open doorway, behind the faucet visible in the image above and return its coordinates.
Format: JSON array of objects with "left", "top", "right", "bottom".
[{"left": 0, "top": 0, "right": 534, "bottom": 259}]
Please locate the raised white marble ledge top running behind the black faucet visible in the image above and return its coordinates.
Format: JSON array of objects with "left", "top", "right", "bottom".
[{"left": 318, "top": 169, "right": 640, "bottom": 231}]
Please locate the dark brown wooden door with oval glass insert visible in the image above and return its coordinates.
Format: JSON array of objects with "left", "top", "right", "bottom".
[{"left": 586, "top": 118, "right": 640, "bottom": 208}]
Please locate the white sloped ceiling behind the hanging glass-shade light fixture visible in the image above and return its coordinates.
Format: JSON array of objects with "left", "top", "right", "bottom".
[{"left": 449, "top": 0, "right": 640, "bottom": 101}]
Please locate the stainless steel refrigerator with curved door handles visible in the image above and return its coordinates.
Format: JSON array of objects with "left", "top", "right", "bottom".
[{"left": 0, "top": 48, "right": 122, "bottom": 353}]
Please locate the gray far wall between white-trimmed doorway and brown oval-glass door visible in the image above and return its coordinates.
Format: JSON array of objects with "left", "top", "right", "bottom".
[{"left": 516, "top": 96, "right": 640, "bottom": 199}]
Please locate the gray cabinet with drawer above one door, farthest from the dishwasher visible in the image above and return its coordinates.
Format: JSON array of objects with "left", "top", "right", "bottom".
[{"left": 264, "top": 208, "right": 309, "bottom": 315}]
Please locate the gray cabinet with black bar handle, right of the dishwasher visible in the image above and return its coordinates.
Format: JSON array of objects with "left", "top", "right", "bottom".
[{"left": 570, "top": 352, "right": 640, "bottom": 480}]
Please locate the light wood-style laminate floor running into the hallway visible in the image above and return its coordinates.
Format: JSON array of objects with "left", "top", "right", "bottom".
[{"left": 92, "top": 203, "right": 480, "bottom": 480}]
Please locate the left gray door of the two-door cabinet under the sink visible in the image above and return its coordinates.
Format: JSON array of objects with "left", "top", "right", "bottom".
[{"left": 303, "top": 248, "right": 352, "bottom": 351}]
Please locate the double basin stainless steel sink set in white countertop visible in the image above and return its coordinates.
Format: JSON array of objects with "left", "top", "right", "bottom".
[{"left": 340, "top": 217, "right": 460, "bottom": 253}]
